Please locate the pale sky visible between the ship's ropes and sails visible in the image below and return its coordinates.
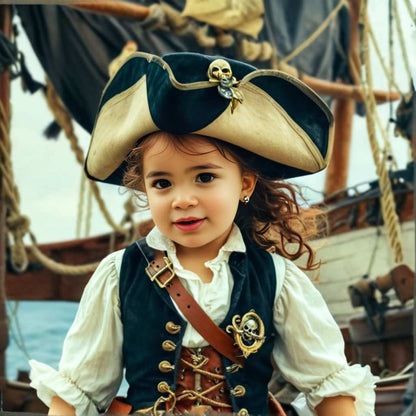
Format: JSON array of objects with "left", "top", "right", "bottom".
[{"left": 6, "top": 0, "right": 416, "bottom": 242}]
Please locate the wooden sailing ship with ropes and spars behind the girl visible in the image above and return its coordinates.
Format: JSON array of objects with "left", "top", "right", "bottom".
[{"left": 0, "top": 0, "right": 416, "bottom": 416}]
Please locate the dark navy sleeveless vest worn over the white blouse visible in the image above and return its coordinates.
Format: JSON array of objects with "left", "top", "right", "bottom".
[{"left": 120, "top": 236, "right": 276, "bottom": 415}]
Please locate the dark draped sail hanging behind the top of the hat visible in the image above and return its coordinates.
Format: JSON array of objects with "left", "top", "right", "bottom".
[{"left": 15, "top": 0, "right": 349, "bottom": 132}]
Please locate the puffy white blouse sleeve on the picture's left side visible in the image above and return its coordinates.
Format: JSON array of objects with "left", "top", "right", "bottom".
[{"left": 29, "top": 251, "right": 123, "bottom": 416}]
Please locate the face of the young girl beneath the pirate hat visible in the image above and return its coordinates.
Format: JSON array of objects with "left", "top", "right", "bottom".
[{"left": 143, "top": 133, "right": 256, "bottom": 256}]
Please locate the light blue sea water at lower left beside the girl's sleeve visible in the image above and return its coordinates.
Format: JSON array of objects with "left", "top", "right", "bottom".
[{"left": 6, "top": 301, "right": 127, "bottom": 395}]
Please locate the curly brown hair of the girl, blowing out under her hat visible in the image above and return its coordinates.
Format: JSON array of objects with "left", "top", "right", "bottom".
[{"left": 123, "top": 132, "right": 326, "bottom": 270}]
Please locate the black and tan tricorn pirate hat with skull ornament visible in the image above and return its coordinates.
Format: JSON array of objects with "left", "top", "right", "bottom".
[{"left": 85, "top": 52, "right": 333, "bottom": 184}]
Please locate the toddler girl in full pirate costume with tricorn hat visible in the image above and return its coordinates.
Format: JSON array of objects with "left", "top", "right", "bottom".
[{"left": 31, "top": 53, "right": 375, "bottom": 416}]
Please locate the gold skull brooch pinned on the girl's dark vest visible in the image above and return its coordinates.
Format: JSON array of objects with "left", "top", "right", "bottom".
[{"left": 226, "top": 309, "right": 266, "bottom": 358}]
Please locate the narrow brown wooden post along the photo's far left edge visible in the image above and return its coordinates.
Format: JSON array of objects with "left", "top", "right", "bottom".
[{"left": 0, "top": 1, "right": 11, "bottom": 402}]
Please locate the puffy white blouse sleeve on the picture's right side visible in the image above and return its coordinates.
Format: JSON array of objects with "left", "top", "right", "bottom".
[{"left": 273, "top": 255, "right": 377, "bottom": 416}]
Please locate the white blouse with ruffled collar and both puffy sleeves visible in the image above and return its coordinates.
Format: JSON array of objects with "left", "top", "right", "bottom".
[{"left": 29, "top": 226, "right": 377, "bottom": 416}]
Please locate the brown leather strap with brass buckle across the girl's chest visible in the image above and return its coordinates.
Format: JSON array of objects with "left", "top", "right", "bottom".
[{"left": 137, "top": 242, "right": 244, "bottom": 370}]
